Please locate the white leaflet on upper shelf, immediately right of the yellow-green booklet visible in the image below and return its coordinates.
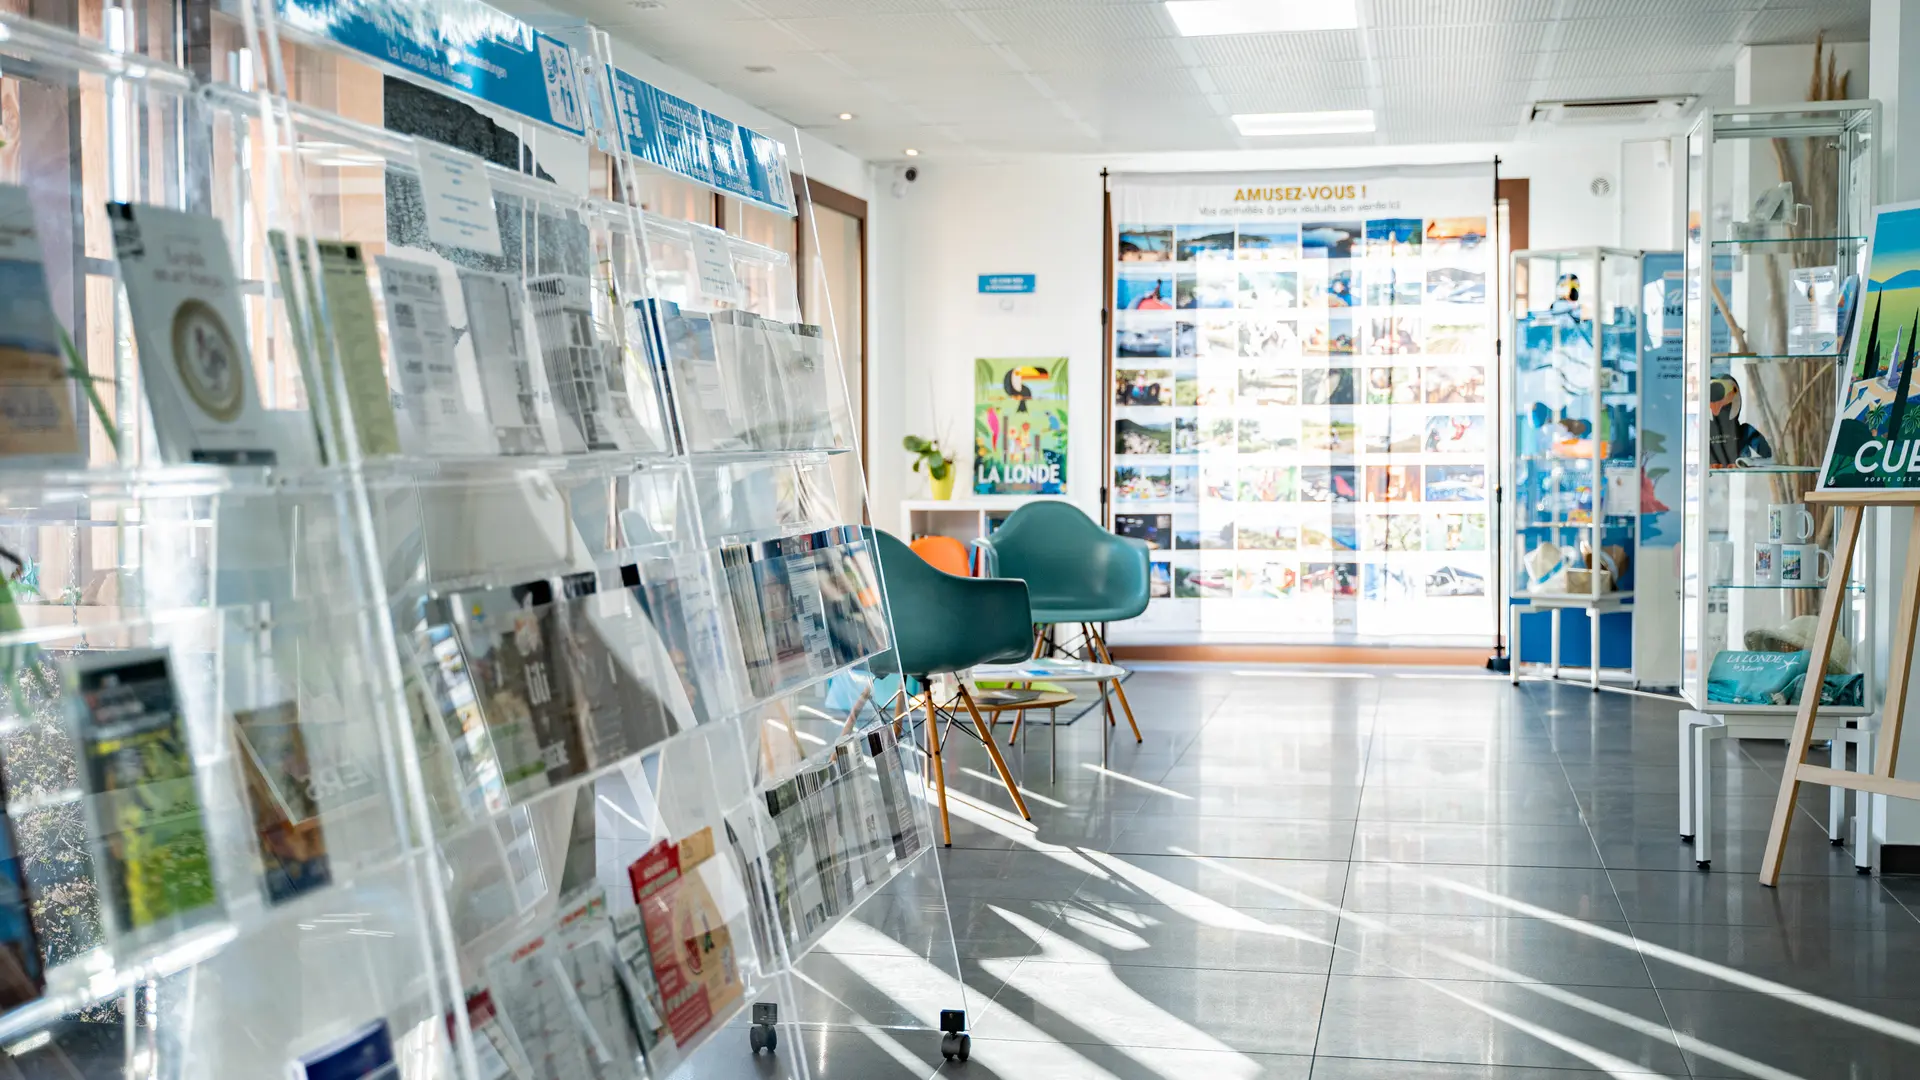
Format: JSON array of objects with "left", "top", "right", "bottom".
[{"left": 374, "top": 256, "right": 495, "bottom": 455}]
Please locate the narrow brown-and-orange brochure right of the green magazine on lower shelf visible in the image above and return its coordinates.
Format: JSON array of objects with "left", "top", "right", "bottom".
[{"left": 234, "top": 701, "right": 332, "bottom": 903}]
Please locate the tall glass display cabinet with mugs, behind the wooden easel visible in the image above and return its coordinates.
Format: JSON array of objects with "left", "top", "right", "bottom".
[{"left": 1680, "top": 102, "right": 1880, "bottom": 867}]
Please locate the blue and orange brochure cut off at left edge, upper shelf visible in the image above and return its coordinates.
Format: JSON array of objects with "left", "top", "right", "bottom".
[{"left": 0, "top": 184, "right": 84, "bottom": 469}]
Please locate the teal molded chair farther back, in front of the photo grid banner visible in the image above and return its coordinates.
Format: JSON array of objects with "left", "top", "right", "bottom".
[{"left": 979, "top": 500, "right": 1150, "bottom": 742}]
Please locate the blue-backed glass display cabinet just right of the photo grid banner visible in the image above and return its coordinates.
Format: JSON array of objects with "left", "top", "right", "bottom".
[{"left": 1505, "top": 248, "right": 1642, "bottom": 690}]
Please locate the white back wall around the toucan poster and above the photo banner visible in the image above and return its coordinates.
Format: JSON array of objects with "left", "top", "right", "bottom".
[{"left": 868, "top": 136, "right": 1620, "bottom": 527}]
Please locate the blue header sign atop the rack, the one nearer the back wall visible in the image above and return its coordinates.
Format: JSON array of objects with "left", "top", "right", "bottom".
[{"left": 609, "top": 67, "right": 793, "bottom": 213}]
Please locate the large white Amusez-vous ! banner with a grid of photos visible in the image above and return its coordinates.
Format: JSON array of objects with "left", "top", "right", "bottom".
[{"left": 1106, "top": 165, "right": 1498, "bottom": 644}]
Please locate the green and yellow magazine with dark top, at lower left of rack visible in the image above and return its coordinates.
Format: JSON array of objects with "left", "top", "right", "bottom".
[{"left": 67, "top": 650, "right": 223, "bottom": 945}]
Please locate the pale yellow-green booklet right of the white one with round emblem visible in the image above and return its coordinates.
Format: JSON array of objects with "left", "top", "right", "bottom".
[{"left": 267, "top": 229, "right": 399, "bottom": 457}]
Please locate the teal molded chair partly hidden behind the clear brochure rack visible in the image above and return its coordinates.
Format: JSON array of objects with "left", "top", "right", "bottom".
[{"left": 866, "top": 528, "right": 1033, "bottom": 846}]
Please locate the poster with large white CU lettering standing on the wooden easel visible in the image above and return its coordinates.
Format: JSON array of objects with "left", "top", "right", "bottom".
[{"left": 1820, "top": 202, "right": 1920, "bottom": 490}]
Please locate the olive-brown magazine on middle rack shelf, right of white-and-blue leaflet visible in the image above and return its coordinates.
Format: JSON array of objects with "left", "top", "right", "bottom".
[{"left": 453, "top": 580, "right": 588, "bottom": 801}]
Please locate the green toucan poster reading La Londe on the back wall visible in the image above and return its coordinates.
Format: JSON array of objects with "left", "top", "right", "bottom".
[{"left": 973, "top": 357, "right": 1068, "bottom": 496}]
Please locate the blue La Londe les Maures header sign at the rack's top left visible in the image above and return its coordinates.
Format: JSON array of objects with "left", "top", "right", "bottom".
[{"left": 276, "top": 0, "right": 588, "bottom": 135}]
